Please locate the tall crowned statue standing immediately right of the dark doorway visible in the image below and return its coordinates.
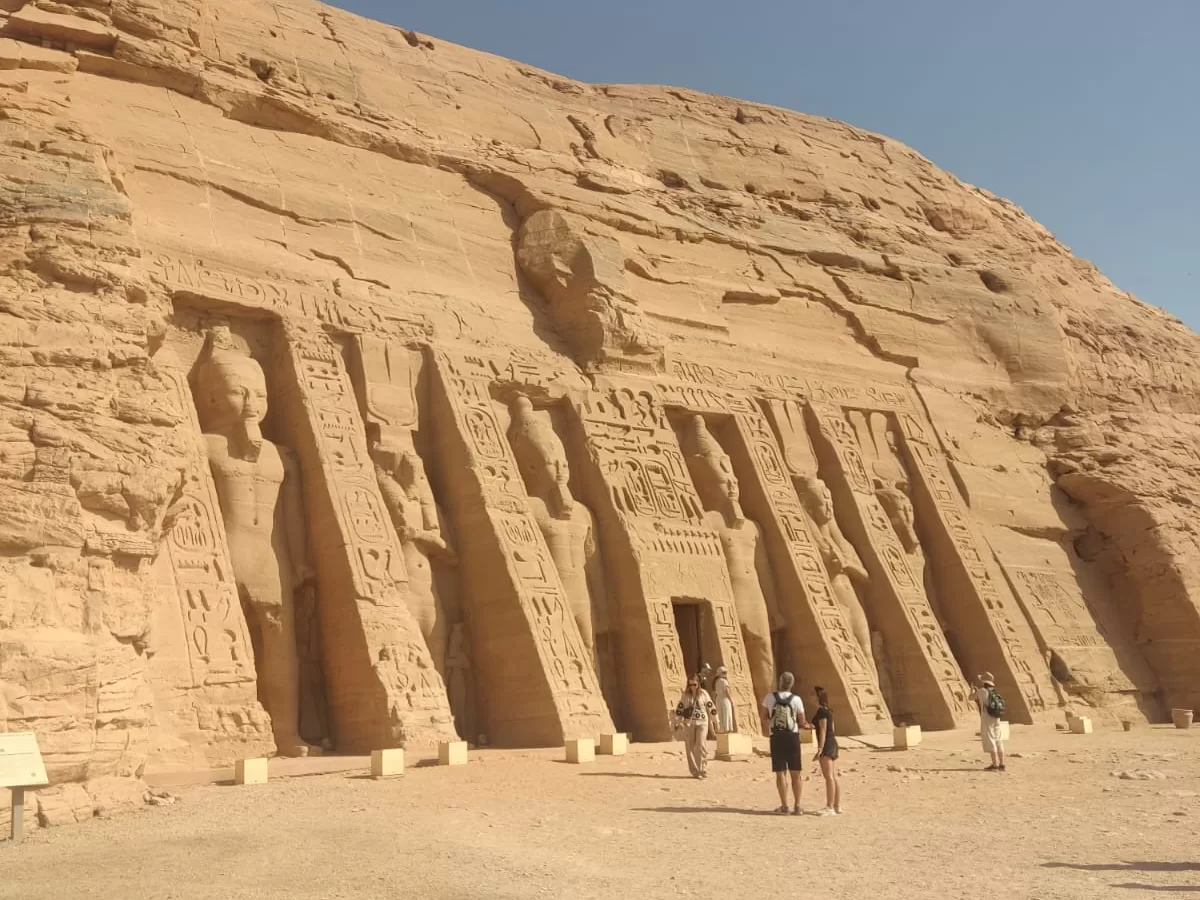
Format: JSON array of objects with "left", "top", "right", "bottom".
[{"left": 684, "top": 415, "right": 780, "bottom": 710}]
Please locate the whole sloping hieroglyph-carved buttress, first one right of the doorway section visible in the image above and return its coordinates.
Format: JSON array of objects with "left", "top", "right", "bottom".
[{"left": 715, "top": 397, "right": 889, "bottom": 734}]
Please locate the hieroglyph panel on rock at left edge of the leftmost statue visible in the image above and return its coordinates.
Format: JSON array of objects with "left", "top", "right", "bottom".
[{"left": 162, "top": 366, "right": 254, "bottom": 686}]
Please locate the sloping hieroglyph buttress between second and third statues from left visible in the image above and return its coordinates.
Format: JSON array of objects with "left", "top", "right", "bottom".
[{"left": 434, "top": 353, "right": 612, "bottom": 746}]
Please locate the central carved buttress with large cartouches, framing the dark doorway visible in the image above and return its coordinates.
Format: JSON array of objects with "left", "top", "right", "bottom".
[{"left": 577, "top": 388, "right": 761, "bottom": 740}]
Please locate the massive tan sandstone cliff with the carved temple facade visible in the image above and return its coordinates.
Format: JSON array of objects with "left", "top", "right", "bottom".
[{"left": 0, "top": 0, "right": 1200, "bottom": 780}]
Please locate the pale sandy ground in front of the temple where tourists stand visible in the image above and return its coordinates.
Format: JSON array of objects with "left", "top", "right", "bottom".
[{"left": 0, "top": 727, "right": 1200, "bottom": 900}]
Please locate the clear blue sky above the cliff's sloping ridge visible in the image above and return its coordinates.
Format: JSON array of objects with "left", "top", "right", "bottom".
[{"left": 335, "top": 0, "right": 1200, "bottom": 329}]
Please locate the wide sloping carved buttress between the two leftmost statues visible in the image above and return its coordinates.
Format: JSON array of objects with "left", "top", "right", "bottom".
[{"left": 280, "top": 320, "right": 455, "bottom": 752}]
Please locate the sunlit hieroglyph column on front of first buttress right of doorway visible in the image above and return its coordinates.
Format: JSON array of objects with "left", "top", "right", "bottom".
[{"left": 734, "top": 403, "right": 883, "bottom": 728}]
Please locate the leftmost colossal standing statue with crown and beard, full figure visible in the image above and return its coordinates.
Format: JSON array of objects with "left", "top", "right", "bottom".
[{"left": 194, "top": 328, "right": 313, "bottom": 756}]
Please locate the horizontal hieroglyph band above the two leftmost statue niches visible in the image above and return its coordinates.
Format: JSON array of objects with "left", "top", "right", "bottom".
[{"left": 149, "top": 254, "right": 430, "bottom": 337}]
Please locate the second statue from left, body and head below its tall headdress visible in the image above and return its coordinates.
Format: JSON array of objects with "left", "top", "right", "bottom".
[{"left": 371, "top": 431, "right": 457, "bottom": 679}]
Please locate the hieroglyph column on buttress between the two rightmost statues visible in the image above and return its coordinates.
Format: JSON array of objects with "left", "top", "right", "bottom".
[{"left": 809, "top": 403, "right": 970, "bottom": 724}]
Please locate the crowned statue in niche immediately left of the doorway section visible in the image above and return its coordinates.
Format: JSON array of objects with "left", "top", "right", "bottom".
[{"left": 509, "top": 394, "right": 611, "bottom": 678}]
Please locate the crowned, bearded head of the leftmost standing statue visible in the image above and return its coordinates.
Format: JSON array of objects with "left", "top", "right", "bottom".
[{"left": 194, "top": 326, "right": 266, "bottom": 456}]
